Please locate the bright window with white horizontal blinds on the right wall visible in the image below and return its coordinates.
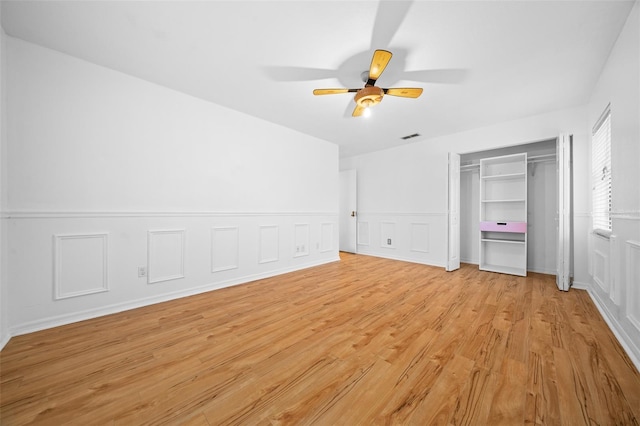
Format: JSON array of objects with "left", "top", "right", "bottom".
[{"left": 591, "top": 105, "right": 611, "bottom": 232}]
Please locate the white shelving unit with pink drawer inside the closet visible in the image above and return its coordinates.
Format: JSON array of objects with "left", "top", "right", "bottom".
[{"left": 480, "top": 153, "right": 527, "bottom": 276}]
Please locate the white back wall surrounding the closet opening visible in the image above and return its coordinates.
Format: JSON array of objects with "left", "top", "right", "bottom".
[{"left": 340, "top": 107, "right": 588, "bottom": 270}]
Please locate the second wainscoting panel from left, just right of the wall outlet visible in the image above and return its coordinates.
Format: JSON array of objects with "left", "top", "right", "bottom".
[{"left": 147, "top": 229, "right": 185, "bottom": 284}]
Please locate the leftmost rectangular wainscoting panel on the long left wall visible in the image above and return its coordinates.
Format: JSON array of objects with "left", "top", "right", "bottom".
[{"left": 53, "top": 233, "right": 109, "bottom": 300}]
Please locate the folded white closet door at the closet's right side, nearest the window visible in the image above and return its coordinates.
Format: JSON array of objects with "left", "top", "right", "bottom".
[{"left": 556, "top": 133, "right": 571, "bottom": 291}]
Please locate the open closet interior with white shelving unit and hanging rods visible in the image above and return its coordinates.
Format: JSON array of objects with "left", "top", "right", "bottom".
[{"left": 460, "top": 139, "right": 558, "bottom": 276}]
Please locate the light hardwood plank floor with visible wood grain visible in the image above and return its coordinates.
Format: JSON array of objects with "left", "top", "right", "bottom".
[{"left": 0, "top": 254, "right": 640, "bottom": 425}]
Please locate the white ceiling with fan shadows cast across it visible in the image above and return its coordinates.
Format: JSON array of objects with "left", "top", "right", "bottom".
[{"left": 2, "top": 0, "right": 633, "bottom": 157}]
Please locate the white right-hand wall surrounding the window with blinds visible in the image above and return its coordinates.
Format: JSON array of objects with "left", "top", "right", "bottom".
[{"left": 577, "top": 1, "right": 640, "bottom": 369}]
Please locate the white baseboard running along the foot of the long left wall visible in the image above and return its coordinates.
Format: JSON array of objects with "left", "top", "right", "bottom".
[{"left": 6, "top": 256, "right": 340, "bottom": 342}]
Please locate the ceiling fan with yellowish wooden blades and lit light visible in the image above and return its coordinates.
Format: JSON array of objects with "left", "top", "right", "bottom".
[{"left": 313, "top": 50, "right": 422, "bottom": 117}]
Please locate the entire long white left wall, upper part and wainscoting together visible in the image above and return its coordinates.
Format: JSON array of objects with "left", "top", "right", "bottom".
[{"left": 2, "top": 37, "right": 338, "bottom": 342}]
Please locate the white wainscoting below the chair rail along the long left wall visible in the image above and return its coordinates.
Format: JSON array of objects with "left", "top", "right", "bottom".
[{"left": 3, "top": 211, "right": 339, "bottom": 342}]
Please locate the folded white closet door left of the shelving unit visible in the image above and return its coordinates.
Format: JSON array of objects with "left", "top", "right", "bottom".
[{"left": 446, "top": 152, "right": 460, "bottom": 271}]
